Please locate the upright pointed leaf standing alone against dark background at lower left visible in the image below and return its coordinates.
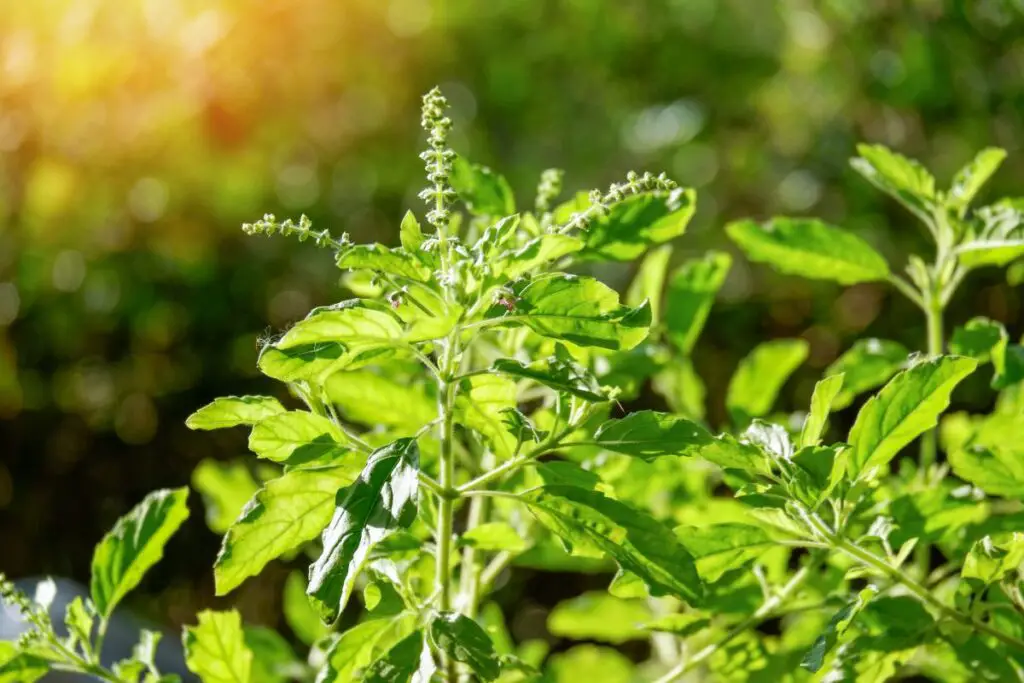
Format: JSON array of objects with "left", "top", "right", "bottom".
[{"left": 90, "top": 488, "right": 188, "bottom": 617}]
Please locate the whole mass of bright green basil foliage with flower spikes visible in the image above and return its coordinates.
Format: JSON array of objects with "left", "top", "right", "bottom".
[{"left": 6, "top": 91, "right": 1024, "bottom": 683}]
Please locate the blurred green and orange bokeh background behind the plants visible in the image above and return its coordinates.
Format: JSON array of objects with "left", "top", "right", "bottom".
[{"left": 0, "top": 0, "right": 1024, "bottom": 651}]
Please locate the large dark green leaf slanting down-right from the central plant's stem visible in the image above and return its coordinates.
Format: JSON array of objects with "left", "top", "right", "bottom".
[{"left": 522, "top": 485, "right": 703, "bottom": 603}]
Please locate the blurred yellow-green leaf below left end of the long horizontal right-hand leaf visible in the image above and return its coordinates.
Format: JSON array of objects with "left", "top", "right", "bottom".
[{"left": 725, "top": 339, "right": 809, "bottom": 425}]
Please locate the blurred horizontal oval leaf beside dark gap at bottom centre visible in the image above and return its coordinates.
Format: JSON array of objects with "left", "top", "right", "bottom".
[{"left": 548, "top": 591, "right": 653, "bottom": 645}]
